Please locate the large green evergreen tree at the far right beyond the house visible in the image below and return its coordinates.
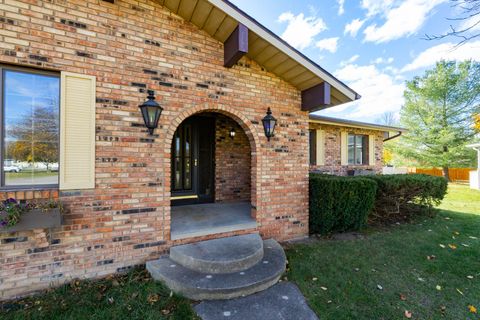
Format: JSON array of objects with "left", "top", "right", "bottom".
[{"left": 398, "top": 61, "right": 480, "bottom": 179}]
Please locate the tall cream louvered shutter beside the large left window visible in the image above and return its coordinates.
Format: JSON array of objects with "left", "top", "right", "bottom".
[{"left": 60, "top": 72, "right": 96, "bottom": 190}]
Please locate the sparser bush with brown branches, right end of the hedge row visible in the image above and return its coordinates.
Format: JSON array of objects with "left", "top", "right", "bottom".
[{"left": 366, "top": 174, "right": 448, "bottom": 224}]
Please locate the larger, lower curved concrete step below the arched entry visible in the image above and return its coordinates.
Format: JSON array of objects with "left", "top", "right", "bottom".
[{"left": 147, "top": 239, "right": 286, "bottom": 300}]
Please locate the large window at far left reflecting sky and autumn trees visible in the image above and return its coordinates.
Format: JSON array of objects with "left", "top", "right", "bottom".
[{"left": 0, "top": 66, "right": 60, "bottom": 187}]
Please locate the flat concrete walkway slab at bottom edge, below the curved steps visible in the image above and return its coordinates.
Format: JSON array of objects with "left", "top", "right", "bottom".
[{"left": 195, "top": 282, "right": 318, "bottom": 320}]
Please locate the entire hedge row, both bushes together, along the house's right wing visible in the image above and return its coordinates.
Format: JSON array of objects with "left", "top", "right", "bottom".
[{"left": 310, "top": 174, "right": 448, "bottom": 234}]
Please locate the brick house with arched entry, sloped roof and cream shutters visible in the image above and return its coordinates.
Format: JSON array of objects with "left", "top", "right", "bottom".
[{"left": 0, "top": 0, "right": 404, "bottom": 299}]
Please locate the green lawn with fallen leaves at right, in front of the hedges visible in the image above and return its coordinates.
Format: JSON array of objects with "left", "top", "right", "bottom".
[{"left": 287, "top": 185, "right": 480, "bottom": 319}]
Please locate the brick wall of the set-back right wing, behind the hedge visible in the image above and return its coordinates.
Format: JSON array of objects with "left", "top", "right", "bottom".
[{"left": 310, "top": 123, "right": 383, "bottom": 175}]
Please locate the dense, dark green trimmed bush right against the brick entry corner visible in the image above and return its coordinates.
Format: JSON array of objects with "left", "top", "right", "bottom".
[{"left": 310, "top": 174, "right": 377, "bottom": 234}]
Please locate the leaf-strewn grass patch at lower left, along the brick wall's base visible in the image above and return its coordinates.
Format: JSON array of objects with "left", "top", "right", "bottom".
[{"left": 0, "top": 269, "right": 198, "bottom": 320}]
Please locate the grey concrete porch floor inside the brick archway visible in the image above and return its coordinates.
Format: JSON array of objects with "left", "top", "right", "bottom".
[{"left": 171, "top": 202, "right": 257, "bottom": 240}]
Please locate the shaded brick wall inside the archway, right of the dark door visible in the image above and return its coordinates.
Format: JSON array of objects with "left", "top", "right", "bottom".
[{"left": 215, "top": 116, "right": 251, "bottom": 202}]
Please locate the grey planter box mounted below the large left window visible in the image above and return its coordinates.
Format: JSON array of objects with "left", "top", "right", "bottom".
[{"left": 0, "top": 208, "right": 63, "bottom": 233}]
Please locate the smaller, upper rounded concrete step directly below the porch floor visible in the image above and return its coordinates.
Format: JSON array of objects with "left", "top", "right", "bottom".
[{"left": 170, "top": 233, "right": 263, "bottom": 274}]
